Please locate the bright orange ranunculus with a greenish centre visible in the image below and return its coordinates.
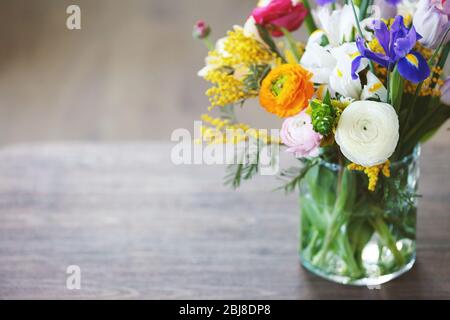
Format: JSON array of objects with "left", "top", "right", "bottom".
[{"left": 259, "top": 64, "right": 314, "bottom": 118}]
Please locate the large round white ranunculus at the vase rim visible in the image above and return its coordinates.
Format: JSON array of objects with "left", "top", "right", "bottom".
[{"left": 335, "top": 101, "right": 399, "bottom": 167}]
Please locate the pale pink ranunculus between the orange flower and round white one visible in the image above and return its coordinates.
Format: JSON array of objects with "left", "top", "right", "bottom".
[{"left": 280, "top": 111, "right": 322, "bottom": 158}]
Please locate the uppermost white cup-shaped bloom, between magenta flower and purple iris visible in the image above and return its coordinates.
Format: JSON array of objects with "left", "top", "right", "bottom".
[{"left": 313, "top": 5, "right": 358, "bottom": 47}]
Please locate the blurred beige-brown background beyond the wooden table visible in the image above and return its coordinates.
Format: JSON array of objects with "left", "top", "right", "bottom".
[{"left": 0, "top": 0, "right": 446, "bottom": 145}]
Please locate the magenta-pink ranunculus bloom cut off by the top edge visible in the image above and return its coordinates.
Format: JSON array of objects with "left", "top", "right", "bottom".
[{"left": 251, "top": 0, "right": 308, "bottom": 37}]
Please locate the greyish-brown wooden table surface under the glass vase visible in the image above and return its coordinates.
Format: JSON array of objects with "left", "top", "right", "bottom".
[{"left": 0, "top": 143, "right": 450, "bottom": 299}]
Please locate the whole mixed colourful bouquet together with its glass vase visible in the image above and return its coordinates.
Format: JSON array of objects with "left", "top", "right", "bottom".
[{"left": 194, "top": 0, "right": 450, "bottom": 285}]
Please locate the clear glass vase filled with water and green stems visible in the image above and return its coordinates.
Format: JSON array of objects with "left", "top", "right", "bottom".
[{"left": 300, "top": 146, "right": 420, "bottom": 286}]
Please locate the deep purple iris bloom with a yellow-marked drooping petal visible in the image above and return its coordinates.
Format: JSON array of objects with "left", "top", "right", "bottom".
[{"left": 352, "top": 16, "right": 430, "bottom": 83}]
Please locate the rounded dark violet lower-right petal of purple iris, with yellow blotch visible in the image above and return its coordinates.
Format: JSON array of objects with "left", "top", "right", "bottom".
[{"left": 398, "top": 51, "right": 430, "bottom": 83}]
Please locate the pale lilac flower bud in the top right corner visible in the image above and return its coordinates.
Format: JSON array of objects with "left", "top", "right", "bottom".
[{"left": 413, "top": 0, "right": 450, "bottom": 49}]
